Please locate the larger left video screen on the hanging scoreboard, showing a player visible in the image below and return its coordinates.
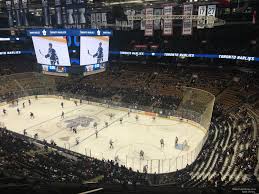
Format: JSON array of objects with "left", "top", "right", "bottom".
[{"left": 32, "top": 36, "right": 70, "bottom": 66}]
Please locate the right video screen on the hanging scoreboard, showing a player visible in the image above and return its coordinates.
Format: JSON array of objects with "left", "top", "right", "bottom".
[{"left": 80, "top": 36, "right": 109, "bottom": 65}]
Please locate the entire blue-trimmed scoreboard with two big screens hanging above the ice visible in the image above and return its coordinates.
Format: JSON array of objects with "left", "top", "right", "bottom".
[{"left": 27, "top": 29, "right": 112, "bottom": 76}]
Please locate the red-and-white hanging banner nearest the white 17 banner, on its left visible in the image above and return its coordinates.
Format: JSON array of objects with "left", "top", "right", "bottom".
[{"left": 182, "top": 4, "right": 193, "bottom": 35}]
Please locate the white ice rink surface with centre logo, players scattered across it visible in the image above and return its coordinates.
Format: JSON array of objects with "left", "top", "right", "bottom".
[{"left": 0, "top": 97, "right": 205, "bottom": 173}]
